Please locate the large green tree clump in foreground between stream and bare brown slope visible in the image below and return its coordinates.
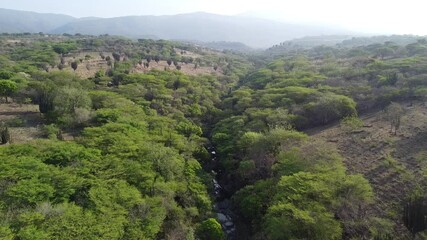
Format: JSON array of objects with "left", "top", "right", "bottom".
[{"left": 235, "top": 138, "right": 373, "bottom": 239}]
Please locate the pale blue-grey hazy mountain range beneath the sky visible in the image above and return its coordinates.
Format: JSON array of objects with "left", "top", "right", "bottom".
[{"left": 0, "top": 9, "right": 350, "bottom": 48}]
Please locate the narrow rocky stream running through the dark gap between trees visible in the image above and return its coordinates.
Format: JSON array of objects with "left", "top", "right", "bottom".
[{"left": 209, "top": 147, "right": 237, "bottom": 240}]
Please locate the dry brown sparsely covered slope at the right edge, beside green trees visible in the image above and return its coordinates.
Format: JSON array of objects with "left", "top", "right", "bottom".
[{"left": 311, "top": 103, "right": 427, "bottom": 236}]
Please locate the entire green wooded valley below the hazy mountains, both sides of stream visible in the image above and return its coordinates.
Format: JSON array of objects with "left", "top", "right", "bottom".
[{"left": 0, "top": 33, "right": 427, "bottom": 240}]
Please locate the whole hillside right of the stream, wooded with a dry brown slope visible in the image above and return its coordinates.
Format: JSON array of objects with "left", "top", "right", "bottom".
[{"left": 212, "top": 36, "right": 427, "bottom": 239}]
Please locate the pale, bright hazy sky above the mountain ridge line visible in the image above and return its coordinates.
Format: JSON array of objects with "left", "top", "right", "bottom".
[{"left": 0, "top": 0, "right": 427, "bottom": 35}]
